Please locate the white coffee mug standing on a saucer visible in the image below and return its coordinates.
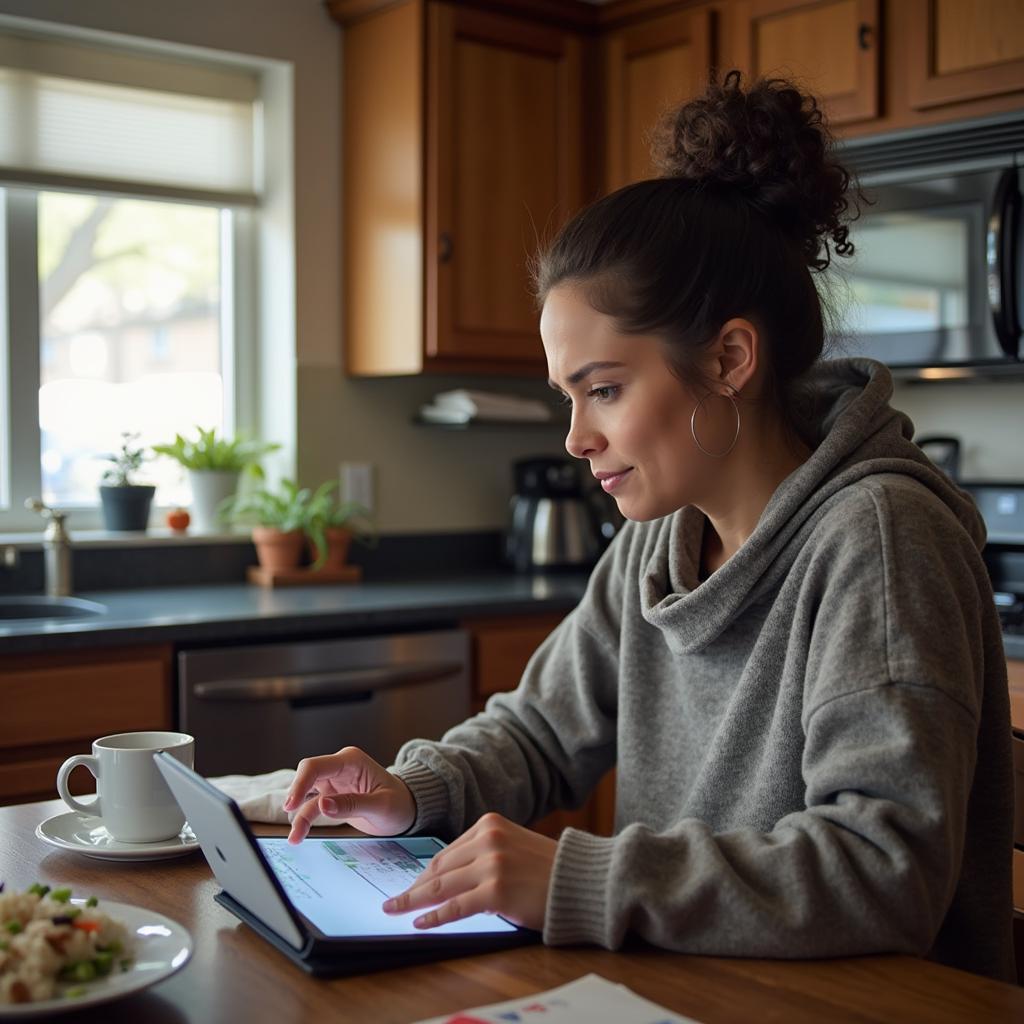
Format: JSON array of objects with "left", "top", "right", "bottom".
[{"left": 57, "top": 732, "right": 196, "bottom": 843}]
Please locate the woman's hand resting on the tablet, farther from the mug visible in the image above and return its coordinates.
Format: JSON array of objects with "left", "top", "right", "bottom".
[{"left": 384, "top": 814, "right": 558, "bottom": 931}]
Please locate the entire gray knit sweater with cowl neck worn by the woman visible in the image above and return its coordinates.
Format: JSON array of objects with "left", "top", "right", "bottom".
[{"left": 392, "top": 359, "right": 1013, "bottom": 980}]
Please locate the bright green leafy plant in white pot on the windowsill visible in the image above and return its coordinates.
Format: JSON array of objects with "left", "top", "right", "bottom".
[{"left": 153, "top": 427, "right": 281, "bottom": 534}]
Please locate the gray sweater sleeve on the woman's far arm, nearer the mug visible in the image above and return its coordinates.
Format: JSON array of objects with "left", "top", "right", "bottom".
[{"left": 390, "top": 530, "right": 628, "bottom": 836}]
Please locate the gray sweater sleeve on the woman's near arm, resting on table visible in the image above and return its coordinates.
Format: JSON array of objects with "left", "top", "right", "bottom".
[{"left": 544, "top": 479, "right": 999, "bottom": 957}]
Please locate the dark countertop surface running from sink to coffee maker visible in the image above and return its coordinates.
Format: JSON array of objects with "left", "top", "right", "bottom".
[{"left": 0, "top": 573, "right": 587, "bottom": 655}]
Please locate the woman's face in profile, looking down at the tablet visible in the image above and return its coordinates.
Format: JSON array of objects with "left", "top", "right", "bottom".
[{"left": 541, "top": 284, "right": 709, "bottom": 521}]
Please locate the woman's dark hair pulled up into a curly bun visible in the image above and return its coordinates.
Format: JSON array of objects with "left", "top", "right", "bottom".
[{"left": 535, "top": 71, "right": 863, "bottom": 430}]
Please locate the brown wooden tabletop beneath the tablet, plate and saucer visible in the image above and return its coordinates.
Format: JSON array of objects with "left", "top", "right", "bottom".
[{"left": 0, "top": 801, "right": 1024, "bottom": 1024}]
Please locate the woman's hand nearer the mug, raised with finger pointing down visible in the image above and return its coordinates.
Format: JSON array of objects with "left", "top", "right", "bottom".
[{"left": 284, "top": 746, "right": 416, "bottom": 843}]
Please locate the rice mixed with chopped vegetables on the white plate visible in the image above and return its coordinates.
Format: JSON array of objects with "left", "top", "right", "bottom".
[{"left": 0, "top": 885, "right": 131, "bottom": 1006}]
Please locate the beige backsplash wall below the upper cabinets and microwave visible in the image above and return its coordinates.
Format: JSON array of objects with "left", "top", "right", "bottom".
[{"left": 298, "top": 366, "right": 1024, "bottom": 532}]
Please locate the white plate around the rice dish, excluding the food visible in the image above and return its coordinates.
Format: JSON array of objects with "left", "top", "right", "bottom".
[{"left": 0, "top": 899, "right": 193, "bottom": 1021}]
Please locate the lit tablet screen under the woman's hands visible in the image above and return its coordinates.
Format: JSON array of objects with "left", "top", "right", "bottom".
[{"left": 256, "top": 837, "right": 516, "bottom": 938}]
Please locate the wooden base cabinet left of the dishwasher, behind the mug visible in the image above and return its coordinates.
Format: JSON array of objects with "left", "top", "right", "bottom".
[{"left": 0, "top": 646, "right": 172, "bottom": 804}]
